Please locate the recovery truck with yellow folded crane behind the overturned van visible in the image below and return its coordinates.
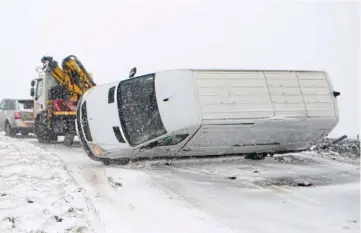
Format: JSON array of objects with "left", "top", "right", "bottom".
[{"left": 30, "top": 55, "right": 96, "bottom": 146}]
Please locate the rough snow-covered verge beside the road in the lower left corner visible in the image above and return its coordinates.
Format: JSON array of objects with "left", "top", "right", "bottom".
[{"left": 0, "top": 135, "right": 95, "bottom": 233}]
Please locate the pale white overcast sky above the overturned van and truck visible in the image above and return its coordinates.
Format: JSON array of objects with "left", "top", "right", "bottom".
[{"left": 0, "top": 0, "right": 360, "bottom": 136}]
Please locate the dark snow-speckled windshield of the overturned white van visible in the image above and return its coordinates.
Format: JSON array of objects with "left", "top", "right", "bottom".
[{"left": 117, "top": 74, "right": 167, "bottom": 146}]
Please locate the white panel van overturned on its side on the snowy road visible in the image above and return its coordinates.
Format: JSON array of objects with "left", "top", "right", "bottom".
[{"left": 77, "top": 70, "right": 340, "bottom": 163}]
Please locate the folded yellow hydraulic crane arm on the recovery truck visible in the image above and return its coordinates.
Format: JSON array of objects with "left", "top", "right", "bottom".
[{"left": 41, "top": 55, "right": 96, "bottom": 101}]
